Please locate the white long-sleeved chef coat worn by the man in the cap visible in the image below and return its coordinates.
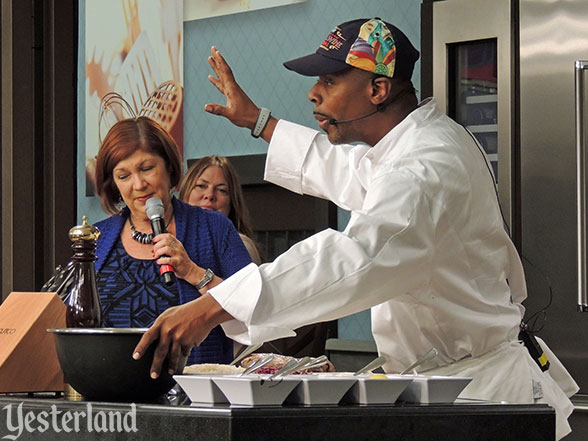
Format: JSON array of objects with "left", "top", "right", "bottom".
[{"left": 209, "top": 99, "right": 577, "bottom": 436}]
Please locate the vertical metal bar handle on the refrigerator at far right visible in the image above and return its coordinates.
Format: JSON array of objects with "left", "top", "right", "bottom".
[{"left": 575, "top": 60, "right": 588, "bottom": 312}]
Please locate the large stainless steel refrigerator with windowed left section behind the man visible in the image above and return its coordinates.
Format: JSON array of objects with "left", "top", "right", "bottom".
[{"left": 423, "top": 0, "right": 588, "bottom": 439}]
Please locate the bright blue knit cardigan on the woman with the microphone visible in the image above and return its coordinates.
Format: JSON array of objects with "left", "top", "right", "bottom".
[{"left": 95, "top": 197, "right": 251, "bottom": 364}]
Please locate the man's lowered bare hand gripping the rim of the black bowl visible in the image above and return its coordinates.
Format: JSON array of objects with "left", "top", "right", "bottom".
[{"left": 133, "top": 293, "right": 233, "bottom": 379}]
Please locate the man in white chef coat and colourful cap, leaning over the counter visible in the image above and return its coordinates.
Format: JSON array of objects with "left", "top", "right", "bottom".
[{"left": 134, "top": 19, "right": 578, "bottom": 439}]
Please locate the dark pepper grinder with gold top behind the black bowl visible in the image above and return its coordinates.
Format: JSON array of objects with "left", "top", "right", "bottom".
[{"left": 65, "top": 216, "right": 102, "bottom": 328}]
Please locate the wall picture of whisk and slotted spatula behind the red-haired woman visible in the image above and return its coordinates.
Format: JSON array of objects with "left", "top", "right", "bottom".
[{"left": 85, "top": 0, "right": 184, "bottom": 196}]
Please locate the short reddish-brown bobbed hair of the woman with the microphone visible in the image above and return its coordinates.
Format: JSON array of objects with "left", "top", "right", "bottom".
[{"left": 95, "top": 116, "right": 182, "bottom": 214}]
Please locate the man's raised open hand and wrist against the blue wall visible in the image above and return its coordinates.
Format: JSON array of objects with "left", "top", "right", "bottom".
[{"left": 204, "top": 46, "right": 278, "bottom": 142}]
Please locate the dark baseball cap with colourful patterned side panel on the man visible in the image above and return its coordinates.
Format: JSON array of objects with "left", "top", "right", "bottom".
[{"left": 284, "top": 17, "right": 419, "bottom": 80}]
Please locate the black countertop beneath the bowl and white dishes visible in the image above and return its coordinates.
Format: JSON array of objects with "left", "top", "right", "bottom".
[{"left": 0, "top": 395, "right": 555, "bottom": 441}]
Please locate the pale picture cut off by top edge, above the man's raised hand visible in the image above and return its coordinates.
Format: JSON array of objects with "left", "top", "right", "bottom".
[{"left": 184, "top": 0, "right": 306, "bottom": 21}]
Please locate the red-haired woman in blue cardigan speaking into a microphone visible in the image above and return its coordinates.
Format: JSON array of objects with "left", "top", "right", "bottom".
[{"left": 96, "top": 117, "right": 251, "bottom": 364}]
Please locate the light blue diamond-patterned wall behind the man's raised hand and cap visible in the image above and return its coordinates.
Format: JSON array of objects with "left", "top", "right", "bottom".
[{"left": 78, "top": 0, "right": 421, "bottom": 339}]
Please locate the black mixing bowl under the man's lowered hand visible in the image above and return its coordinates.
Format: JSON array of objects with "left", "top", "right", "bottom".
[{"left": 48, "top": 328, "right": 186, "bottom": 401}]
